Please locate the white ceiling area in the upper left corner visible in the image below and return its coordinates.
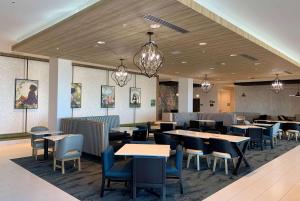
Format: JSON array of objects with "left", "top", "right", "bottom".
[{"left": 0, "top": 0, "right": 99, "bottom": 51}]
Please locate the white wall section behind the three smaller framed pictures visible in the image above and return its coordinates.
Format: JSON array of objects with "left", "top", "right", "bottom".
[{"left": 73, "top": 66, "right": 156, "bottom": 124}]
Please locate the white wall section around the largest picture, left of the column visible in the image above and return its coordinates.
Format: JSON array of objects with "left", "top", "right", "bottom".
[{"left": 0, "top": 56, "right": 49, "bottom": 134}]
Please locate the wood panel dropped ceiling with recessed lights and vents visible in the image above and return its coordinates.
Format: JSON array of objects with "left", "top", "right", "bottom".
[{"left": 12, "top": 0, "right": 300, "bottom": 81}]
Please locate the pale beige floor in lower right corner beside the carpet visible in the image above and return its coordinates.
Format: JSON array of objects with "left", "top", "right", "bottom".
[{"left": 204, "top": 146, "right": 300, "bottom": 201}]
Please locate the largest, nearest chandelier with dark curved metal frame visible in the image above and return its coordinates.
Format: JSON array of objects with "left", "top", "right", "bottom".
[{"left": 133, "top": 32, "right": 164, "bottom": 78}]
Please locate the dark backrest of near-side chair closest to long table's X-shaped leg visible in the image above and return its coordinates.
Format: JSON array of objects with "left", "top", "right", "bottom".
[{"left": 209, "top": 138, "right": 238, "bottom": 158}]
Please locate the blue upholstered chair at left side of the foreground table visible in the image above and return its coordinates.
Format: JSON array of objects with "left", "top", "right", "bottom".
[{"left": 100, "top": 146, "right": 132, "bottom": 197}]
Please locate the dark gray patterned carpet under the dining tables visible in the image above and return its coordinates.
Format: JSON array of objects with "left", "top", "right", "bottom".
[{"left": 12, "top": 140, "right": 298, "bottom": 201}]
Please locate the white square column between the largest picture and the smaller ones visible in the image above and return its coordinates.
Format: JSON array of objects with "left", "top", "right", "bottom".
[{"left": 48, "top": 58, "right": 72, "bottom": 130}]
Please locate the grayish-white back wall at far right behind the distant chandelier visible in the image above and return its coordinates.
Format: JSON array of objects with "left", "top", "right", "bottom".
[{"left": 235, "top": 84, "right": 300, "bottom": 116}]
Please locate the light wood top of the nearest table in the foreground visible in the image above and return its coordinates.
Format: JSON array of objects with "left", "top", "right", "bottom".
[{"left": 115, "top": 144, "right": 170, "bottom": 157}]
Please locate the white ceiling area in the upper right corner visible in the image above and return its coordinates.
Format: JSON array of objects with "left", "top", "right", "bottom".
[{"left": 195, "top": 0, "right": 300, "bottom": 66}]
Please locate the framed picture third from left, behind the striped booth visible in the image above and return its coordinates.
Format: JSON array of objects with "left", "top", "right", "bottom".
[{"left": 101, "top": 85, "right": 115, "bottom": 108}]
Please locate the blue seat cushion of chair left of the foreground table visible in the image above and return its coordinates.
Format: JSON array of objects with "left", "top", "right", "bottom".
[{"left": 105, "top": 159, "right": 132, "bottom": 178}]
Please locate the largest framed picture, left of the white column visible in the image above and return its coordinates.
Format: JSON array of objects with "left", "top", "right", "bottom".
[{"left": 14, "top": 79, "right": 39, "bottom": 109}]
